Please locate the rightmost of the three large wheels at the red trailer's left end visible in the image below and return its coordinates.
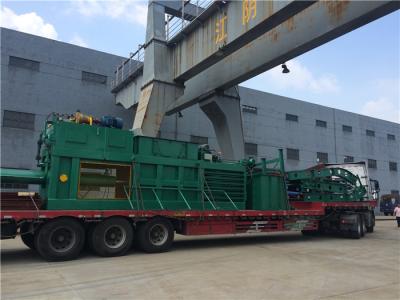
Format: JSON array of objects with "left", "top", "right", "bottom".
[{"left": 137, "top": 218, "right": 174, "bottom": 253}]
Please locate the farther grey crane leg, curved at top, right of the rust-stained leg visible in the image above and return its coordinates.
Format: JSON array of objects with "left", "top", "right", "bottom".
[{"left": 199, "top": 88, "right": 244, "bottom": 160}]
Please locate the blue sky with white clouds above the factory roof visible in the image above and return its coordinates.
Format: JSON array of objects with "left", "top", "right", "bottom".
[{"left": 1, "top": 0, "right": 400, "bottom": 123}]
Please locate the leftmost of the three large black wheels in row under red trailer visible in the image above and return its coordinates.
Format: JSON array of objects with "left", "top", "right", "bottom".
[{"left": 35, "top": 218, "right": 85, "bottom": 261}]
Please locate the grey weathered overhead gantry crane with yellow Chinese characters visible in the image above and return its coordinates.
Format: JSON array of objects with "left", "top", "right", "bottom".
[{"left": 113, "top": 0, "right": 400, "bottom": 159}]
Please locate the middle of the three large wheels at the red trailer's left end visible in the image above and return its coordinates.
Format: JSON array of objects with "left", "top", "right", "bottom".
[{"left": 89, "top": 217, "right": 133, "bottom": 256}]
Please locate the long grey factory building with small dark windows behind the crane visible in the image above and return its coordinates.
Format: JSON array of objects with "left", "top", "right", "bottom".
[{"left": 1, "top": 28, "right": 400, "bottom": 198}]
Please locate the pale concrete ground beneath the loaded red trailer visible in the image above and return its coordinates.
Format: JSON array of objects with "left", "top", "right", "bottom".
[{"left": 1, "top": 220, "right": 400, "bottom": 300}]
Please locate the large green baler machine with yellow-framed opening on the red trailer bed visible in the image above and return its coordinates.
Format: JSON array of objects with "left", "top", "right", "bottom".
[{"left": 0, "top": 114, "right": 362, "bottom": 211}]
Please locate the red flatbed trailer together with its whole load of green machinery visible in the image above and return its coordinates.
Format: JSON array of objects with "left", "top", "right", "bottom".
[{"left": 0, "top": 113, "right": 376, "bottom": 260}]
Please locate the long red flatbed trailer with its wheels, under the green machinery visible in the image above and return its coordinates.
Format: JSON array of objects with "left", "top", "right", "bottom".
[{"left": 0, "top": 200, "right": 376, "bottom": 260}]
